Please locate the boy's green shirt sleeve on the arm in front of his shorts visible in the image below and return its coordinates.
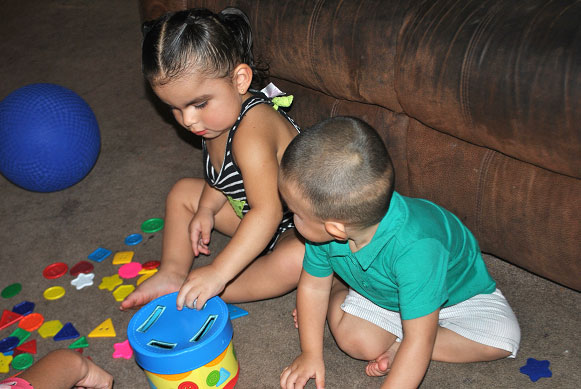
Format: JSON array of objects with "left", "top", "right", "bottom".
[{"left": 393, "top": 239, "right": 448, "bottom": 320}]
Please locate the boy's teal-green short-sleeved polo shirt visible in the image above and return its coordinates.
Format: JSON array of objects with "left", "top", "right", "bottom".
[{"left": 303, "top": 192, "right": 496, "bottom": 320}]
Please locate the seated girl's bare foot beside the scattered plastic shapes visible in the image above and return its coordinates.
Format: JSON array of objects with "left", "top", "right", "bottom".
[{"left": 119, "top": 270, "right": 186, "bottom": 311}]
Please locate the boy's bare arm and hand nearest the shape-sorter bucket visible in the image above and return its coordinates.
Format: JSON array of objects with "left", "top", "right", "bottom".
[{"left": 280, "top": 270, "right": 333, "bottom": 389}]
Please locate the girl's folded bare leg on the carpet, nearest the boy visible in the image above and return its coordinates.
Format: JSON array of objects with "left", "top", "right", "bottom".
[{"left": 220, "top": 228, "right": 305, "bottom": 303}]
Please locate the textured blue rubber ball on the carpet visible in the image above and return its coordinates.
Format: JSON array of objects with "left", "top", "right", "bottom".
[{"left": 0, "top": 84, "right": 101, "bottom": 192}]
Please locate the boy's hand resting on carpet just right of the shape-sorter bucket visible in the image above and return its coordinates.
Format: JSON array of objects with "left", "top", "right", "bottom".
[{"left": 280, "top": 353, "right": 325, "bottom": 389}]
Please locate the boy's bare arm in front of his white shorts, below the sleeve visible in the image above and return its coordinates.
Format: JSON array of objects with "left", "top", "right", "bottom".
[{"left": 381, "top": 309, "right": 440, "bottom": 389}]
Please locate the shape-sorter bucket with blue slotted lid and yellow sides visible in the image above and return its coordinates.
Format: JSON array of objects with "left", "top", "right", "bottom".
[{"left": 127, "top": 292, "right": 239, "bottom": 389}]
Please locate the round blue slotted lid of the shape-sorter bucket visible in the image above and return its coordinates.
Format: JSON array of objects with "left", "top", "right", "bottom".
[{"left": 127, "top": 292, "right": 233, "bottom": 374}]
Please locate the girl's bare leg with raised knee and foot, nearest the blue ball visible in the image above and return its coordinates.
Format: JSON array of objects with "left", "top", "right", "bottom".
[{"left": 121, "top": 178, "right": 240, "bottom": 309}]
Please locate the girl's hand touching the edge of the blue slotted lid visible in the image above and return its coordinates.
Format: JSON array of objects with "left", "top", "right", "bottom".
[{"left": 176, "top": 264, "right": 229, "bottom": 311}]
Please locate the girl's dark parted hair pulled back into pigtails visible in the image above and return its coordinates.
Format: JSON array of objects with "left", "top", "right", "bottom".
[{"left": 142, "top": 8, "right": 268, "bottom": 87}]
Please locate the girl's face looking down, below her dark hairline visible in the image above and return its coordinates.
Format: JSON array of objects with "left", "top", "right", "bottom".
[{"left": 153, "top": 70, "right": 246, "bottom": 139}]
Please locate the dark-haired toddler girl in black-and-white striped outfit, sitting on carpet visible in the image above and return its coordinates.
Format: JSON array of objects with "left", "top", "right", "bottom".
[{"left": 121, "top": 8, "right": 304, "bottom": 309}]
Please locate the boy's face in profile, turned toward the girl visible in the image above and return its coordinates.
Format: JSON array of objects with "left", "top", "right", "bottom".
[{"left": 278, "top": 179, "right": 334, "bottom": 243}]
